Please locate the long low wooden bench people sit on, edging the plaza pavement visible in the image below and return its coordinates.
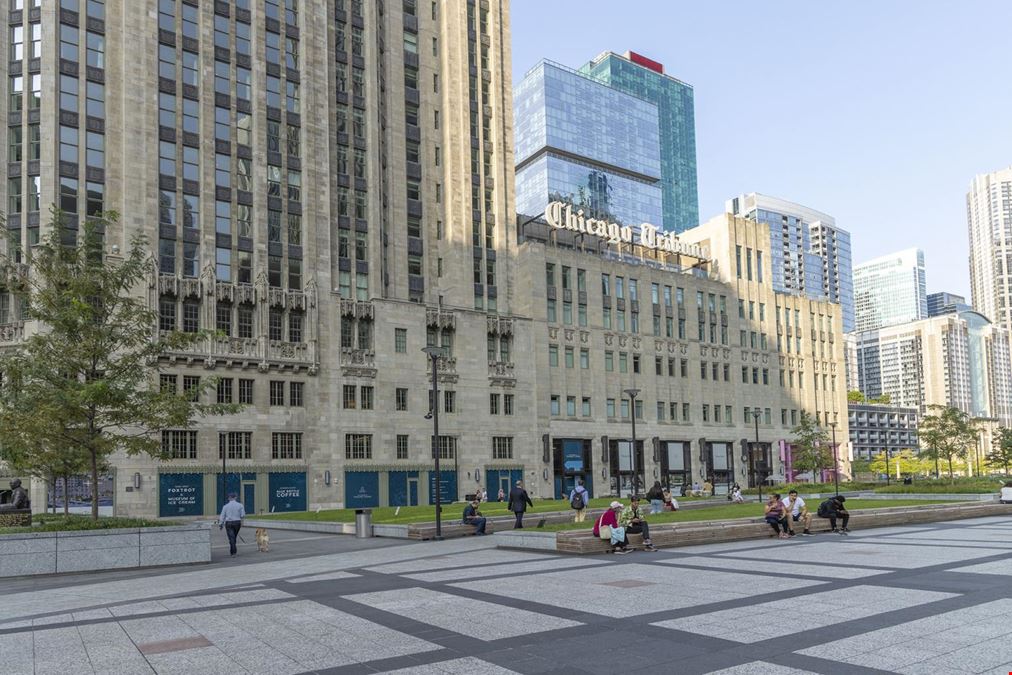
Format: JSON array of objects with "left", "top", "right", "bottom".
[{"left": 556, "top": 503, "right": 1012, "bottom": 556}]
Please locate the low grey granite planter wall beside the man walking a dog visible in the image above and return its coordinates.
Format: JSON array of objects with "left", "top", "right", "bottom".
[{"left": 0, "top": 523, "right": 210, "bottom": 577}]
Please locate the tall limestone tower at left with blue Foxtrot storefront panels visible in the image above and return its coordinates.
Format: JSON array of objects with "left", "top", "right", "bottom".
[{"left": 0, "top": 0, "right": 534, "bottom": 515}]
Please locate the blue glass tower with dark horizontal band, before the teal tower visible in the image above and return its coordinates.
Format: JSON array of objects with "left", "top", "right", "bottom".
[{"left": 513, "top": 61, "right": 664, "bottom": 226}]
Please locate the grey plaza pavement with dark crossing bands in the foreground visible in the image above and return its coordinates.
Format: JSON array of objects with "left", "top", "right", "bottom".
[{"left": 0, "top": 517, "right": 1012, "bottom": 675}]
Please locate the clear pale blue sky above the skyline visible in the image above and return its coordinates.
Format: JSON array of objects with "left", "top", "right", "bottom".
[{"left": 511, "top": 0, "right": 1012, "bottom": 298}]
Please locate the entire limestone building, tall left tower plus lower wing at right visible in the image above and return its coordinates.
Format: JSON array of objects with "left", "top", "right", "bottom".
[{"left": 0, "top": 0, "right": 847, "bottom": 517}]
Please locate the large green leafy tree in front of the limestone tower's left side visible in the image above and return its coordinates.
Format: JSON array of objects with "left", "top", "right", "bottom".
[{"left": 0, "top": 212, "right": 238, "bottom": 519}]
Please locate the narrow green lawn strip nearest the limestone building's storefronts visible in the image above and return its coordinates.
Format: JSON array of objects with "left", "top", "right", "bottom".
[{"left": 251, "top": 497, "right": 701, "bottom": 524}]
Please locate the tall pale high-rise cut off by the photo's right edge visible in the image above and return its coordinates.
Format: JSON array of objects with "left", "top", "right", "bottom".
[{"left": 966, "top": 167, "right": 1012, "bottom": 330}]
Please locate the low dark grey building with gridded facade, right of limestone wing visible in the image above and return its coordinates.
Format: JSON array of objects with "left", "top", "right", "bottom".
[{"left": 847, "top": 403, "right": 920, "bottom": 459}]
